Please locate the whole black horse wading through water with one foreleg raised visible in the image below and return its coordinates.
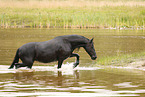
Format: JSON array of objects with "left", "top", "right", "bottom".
[{"left": 9, "top": 35, "right": 97, "bottom": 69}]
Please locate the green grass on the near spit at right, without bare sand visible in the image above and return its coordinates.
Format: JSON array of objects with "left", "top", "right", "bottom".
[{"left": 97, "top": 51, "right": 145, "bottom": 66}]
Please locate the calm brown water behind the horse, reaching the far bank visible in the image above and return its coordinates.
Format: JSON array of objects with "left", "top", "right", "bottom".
[{"left": 0, "top": 29, "right": 145, "bottom": 65}]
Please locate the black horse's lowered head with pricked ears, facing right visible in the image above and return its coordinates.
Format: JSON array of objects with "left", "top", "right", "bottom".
[{"left": 84, "top": 38, "right": 97, "bottom": 60}]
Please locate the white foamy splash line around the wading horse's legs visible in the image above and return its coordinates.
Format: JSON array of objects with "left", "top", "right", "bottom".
[{"left": 0, "top": 63, "right": 101, "bottom": 75}]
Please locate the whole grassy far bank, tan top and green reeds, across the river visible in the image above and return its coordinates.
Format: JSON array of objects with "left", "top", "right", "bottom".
[{"left": 0, "top": 0, "right": 145, "bottom": 29}]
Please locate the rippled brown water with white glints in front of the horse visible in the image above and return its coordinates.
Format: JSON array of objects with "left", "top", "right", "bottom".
[{"left": 0, "top": 65, "right": 145, "bottom": 97}]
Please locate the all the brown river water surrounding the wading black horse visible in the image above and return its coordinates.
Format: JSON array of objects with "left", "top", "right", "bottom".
[{"left": 0, "top": 29, "right": 145, "bottom": 97}]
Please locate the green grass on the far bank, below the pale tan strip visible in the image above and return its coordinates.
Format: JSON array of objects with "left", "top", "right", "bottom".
[{"left": 0, "top": 0, "right": 145, "bottom": 29}]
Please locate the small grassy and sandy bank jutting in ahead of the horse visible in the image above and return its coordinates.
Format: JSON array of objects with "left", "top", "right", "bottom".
[{"left": 97, "top": 52, "right": 145, "bottom": 71}]
